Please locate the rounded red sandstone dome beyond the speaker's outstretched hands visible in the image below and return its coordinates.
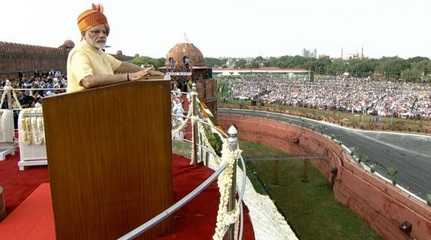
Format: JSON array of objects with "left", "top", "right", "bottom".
[{"left": 166, "top": 43, "right": 205, "bottom": 69}]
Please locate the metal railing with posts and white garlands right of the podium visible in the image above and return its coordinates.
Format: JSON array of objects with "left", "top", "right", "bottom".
[{"left": 119, "top": 84, "right": 246, "bottom": 240}]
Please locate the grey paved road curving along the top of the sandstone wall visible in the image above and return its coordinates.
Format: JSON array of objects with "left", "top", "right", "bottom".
[{"left": 218, "top": 108, "right": 431, "bottom": 199}]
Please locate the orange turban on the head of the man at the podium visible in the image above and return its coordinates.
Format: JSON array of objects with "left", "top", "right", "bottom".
[{"left": 78, "top": 4, "right": 109, "bottom": 33}]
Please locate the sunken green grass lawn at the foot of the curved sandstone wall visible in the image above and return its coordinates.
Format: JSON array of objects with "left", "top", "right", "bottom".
[{"left": 240, "top": 142, "right": 382, "bottom": 240}]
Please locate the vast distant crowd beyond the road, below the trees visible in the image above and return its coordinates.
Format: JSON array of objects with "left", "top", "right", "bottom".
[{"left": 229, "top": 76, "right": 431, "bottom": 118}]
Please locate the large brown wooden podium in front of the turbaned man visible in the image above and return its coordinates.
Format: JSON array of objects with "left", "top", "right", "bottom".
[{"left": 43, "top": 80, "right": 173, "bottom": 240}]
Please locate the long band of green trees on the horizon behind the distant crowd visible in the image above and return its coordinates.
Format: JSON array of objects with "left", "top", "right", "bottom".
[{"left": 199, "top": 54, "right": 431, "bottom": 82}]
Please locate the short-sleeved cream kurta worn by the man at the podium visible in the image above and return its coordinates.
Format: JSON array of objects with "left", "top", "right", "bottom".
[{"left": 67, "top": 40, "right": 121, "bottom": 93}]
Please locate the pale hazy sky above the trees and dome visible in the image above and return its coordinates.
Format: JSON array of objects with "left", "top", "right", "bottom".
[{"left": 0, "top": 0, "right": 431, "bottom": 57}]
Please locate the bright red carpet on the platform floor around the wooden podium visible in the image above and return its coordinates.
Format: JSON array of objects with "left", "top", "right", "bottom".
[{"left": 0, "top": 155, "right": 254, "bottom": 240}]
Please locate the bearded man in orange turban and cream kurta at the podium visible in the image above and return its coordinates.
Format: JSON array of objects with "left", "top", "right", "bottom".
[{"left": 67, "top": 4, "right": 163, "bottom": 92}]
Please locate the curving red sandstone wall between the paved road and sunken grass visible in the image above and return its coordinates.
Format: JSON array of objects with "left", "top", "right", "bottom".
[{"left": 221, "top": 113, "right": 431, "bottom": 240}]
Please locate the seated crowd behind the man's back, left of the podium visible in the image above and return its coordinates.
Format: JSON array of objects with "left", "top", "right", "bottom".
[{"left": 0, "top": 71, "right": 67, "bottom": 108}]
